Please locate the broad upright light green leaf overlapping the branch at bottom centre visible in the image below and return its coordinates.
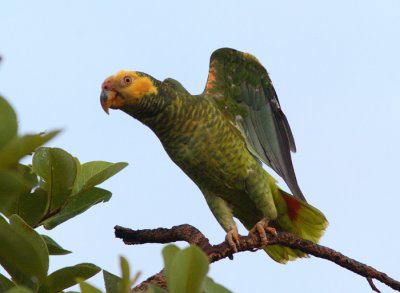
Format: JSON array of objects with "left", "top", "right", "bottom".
[{"left": 165, "top": 245, "right": 209, "bottom": 293}]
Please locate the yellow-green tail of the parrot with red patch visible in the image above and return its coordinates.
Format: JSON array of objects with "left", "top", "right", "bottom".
[{"left": 264, "top": 189, "right": 328, "bottom": 263}]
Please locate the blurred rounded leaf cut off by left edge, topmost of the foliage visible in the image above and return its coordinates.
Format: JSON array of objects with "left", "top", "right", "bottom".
[{"left": 0, "top": 96, "right": 18, "bottom": 149}]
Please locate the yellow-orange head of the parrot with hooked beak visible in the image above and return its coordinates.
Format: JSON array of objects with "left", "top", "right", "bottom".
[{"left": 100, "top": 71, "right": 158, "bottom": 114}]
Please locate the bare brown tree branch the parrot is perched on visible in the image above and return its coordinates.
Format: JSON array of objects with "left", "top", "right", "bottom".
[{"left": 115, "top": 224, "right": 400, "bottom": 292}]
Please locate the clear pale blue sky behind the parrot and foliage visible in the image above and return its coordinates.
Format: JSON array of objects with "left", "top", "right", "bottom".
[{"left": 0, "top": 0, "right": 400, "bottom": 293}]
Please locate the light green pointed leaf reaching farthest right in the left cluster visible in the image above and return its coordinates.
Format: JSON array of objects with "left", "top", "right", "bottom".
[{"left": 73, "top": 161, "right": 128, "bottom": 194}]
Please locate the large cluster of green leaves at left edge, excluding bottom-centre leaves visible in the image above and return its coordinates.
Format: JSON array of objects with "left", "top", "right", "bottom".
[{"left": 0, "top": 97, "right": 127, "bottom": 293}]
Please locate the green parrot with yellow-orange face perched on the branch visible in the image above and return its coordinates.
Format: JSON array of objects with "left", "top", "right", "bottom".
[{"left": 100, "top": 48, "right": 328, "bottom": 264}]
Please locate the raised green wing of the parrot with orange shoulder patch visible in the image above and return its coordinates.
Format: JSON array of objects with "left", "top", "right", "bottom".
[{"left": 203, "top": 48, "right": 305, "bottom": 200}]
